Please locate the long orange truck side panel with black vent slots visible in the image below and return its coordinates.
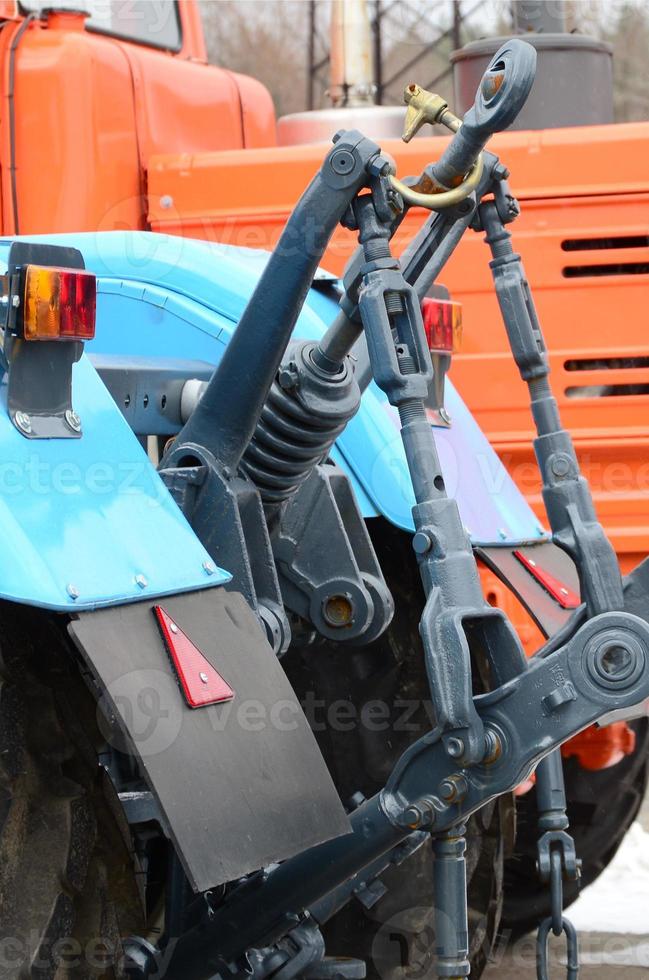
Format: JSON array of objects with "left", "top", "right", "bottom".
[{"left": 148, "top": 123, "right": 649, "bottom": 570}]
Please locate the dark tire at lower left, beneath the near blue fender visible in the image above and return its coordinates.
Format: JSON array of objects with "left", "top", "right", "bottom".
[{"left": 0, "top": 603, "right": 141, "bottom": 980}]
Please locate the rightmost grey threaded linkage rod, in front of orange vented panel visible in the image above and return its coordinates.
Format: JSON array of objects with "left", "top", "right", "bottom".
[{"left": 479, "top": 202, "right": 624, "bottom": 616}]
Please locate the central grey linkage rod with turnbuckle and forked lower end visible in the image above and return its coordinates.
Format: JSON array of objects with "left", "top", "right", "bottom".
[{"left": 354, "top": 188, "right": 526, "bottom": 762}]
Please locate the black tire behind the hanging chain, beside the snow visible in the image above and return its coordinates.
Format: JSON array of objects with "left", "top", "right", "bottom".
[{"left": 502, "top": 718, "right": 649, "bottom": 940}]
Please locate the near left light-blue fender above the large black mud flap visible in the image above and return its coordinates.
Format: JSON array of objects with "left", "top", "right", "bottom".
[{"left": 0, "top": 355, "right": 231, "bottom": 613}]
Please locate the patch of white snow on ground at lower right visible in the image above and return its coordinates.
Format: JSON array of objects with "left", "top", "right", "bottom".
[{"left": 566, "top": 823, "right": 649, "bottom": 936}]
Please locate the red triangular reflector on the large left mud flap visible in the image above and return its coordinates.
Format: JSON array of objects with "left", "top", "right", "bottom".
[{"left": 153, "top": 606, "right": 234, "bottom": 708}]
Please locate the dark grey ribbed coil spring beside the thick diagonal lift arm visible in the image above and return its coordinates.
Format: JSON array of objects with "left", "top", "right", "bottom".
[{"left": 241, "top": 370, "right": 350, "bottom": 503}]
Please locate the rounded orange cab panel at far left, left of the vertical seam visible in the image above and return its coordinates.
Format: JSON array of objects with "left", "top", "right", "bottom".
[{"left": 0, "top": 15, "right": 142, "bottom": 234}]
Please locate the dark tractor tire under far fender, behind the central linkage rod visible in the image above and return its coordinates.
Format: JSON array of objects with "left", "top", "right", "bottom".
[{"left": 282, "top": 520, "right": 513, "bottom": 980}]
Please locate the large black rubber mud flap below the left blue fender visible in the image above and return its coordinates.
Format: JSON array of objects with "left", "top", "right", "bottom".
[{"left": 69, "top": 589, "right": 350, "bottom": 892}]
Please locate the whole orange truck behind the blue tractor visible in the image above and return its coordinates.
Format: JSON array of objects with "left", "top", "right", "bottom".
[{"left": 0, "top": 0, "right": 649, "bottom": 928}]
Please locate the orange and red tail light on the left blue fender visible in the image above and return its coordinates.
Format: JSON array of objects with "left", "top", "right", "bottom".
[{"left": 16, "top": 265, "right": 97, "bottom": 340}]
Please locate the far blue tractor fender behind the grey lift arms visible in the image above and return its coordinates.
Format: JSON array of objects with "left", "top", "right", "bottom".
[{"left": 0, "top": 232, "right": 548, "bottom": 547}]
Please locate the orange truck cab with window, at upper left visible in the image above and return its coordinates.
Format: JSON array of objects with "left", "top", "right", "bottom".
[{"left": 0, "top": 0, "right": 275, "bottom": 234}]
